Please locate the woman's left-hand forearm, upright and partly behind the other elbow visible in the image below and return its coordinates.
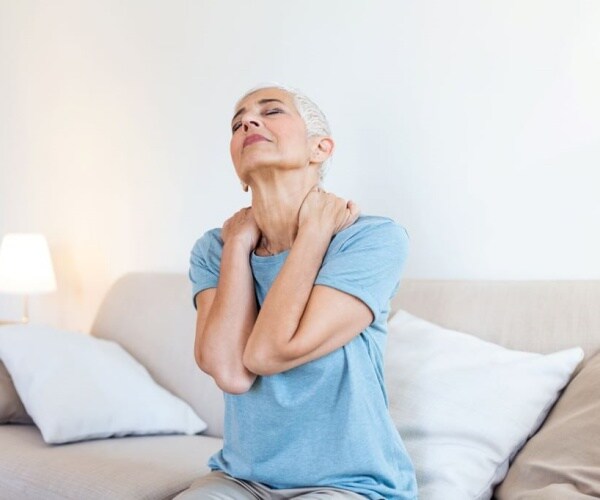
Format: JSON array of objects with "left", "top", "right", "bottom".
[{"left": 197, "top": 239, "right": 257, "bottom": 393}]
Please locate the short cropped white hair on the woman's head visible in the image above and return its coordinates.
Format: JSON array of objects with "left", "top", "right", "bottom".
[{"left": 234, "top": 82, "right": 331, "bottom": 182}]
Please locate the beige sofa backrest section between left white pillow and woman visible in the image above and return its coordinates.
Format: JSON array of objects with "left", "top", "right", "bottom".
[{"left": 91, "top": 273, "right": 224, "bottom": 436}]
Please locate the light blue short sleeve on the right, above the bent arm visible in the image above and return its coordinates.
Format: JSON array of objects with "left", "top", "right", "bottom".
[{"left": 315, "top": 218, "right": 409, "bottom": 322}]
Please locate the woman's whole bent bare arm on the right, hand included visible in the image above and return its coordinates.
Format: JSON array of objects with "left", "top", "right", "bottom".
[{"left": 243, "top": 188, "right": 373, "bottom": 375}]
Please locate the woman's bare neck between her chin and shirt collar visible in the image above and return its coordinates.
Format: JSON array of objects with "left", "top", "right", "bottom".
[{"left": 250, "top": 171, "right": 318, "bottom": 255}]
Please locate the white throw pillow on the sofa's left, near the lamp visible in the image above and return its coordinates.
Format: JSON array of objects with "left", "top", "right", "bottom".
[{"left": 0, "top": 325, "right": 207, "bottom": 444}]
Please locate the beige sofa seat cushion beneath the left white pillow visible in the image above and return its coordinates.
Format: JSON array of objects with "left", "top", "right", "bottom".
[{"left": 0, "top": 424, "right": 222, "bottom": 500}]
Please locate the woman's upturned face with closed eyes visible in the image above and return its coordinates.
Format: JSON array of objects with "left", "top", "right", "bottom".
[{"left": 230, "top": 88, "right": 314, "bottom": 182}]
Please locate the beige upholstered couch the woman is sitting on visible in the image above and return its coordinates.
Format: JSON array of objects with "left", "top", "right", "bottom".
[{"left": 0, "top": 273, "right": 600, "bottom": 500}]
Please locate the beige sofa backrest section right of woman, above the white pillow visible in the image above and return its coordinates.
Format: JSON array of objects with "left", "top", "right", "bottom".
[{"left": 391, "top": 279, "right": 600, "bottom": 372}]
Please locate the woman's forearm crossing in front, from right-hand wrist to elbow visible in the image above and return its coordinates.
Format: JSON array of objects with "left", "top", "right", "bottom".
[{"left": 244, "top": 225, "right": 331, "bottom": 369}]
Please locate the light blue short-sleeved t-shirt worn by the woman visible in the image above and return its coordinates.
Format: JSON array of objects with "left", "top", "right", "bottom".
[{"left": 189, "top": 215, "right": 417, "bottom": 500}]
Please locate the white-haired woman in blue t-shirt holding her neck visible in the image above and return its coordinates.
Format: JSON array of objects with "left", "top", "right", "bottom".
[{"left": 177, "top": 85, "right": 417, "bottom": 500}]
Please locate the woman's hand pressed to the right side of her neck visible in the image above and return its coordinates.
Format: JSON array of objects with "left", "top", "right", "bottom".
[{"left": 298, "top": 186, "right": 360, "bottom": 236}]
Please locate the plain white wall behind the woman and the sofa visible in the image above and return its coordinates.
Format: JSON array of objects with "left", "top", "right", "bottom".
[{"left": 0, "top": 0, "right": 600, "bottom": 331}]
